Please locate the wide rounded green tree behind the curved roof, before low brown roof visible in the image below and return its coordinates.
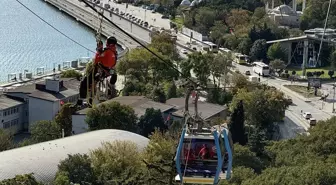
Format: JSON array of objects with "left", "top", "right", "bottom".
[{"left": 85, "top": 101, "right": 137, "bottom": 132}]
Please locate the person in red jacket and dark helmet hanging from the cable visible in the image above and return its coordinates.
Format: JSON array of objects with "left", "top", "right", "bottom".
[{"left": 77, "top": 37, "right": 118, "bottom": 105}]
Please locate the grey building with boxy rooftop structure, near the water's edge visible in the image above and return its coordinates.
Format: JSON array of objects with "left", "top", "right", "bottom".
[{"left": 5, "top": 77, "right": 79, "bottom": 130}]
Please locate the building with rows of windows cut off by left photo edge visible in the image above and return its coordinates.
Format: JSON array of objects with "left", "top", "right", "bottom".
[{"left": 0, "top": 95, "right": 24, "bottom": 134}]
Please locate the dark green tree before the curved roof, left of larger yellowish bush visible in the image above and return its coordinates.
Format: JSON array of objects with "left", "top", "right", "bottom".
[{"left": 55, "top": 154, "right": 97, "bottom": 185}]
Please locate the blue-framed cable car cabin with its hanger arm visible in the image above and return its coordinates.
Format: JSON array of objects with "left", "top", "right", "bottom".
[{"left": 175, "top": 86, "right": 233, "bottom": 185}]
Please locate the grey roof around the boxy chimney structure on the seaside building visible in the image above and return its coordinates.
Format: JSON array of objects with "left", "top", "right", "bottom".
[{"left": 6, "top": 78, "right": 80, "bottom": 101}]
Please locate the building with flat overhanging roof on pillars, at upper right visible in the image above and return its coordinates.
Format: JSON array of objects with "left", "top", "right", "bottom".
[{"left": 267, "top": 28, "right": 336, "bottom": 67}]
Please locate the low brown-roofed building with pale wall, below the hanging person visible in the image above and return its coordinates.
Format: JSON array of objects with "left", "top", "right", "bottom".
[{"left": 72, "top": 96, "right": 174, "bottom": 134}]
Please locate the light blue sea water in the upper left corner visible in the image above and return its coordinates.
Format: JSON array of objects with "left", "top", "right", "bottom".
[{"left": 0, "top": 0, "right": 121, "bottom": 82}]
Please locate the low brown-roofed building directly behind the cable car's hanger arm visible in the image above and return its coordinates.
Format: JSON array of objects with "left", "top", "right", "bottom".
[{"left": 166, "top": 98, "right": 228, "bottom": 121}]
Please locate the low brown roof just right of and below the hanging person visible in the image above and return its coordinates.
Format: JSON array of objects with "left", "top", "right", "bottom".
[{"left": 77, "top": 96, "right": 174, "bottom": 116}]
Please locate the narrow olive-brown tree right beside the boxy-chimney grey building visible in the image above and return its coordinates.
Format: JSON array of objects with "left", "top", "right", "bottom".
[{"left": 55, "top": 103, "right": 76, "bottom": 137}]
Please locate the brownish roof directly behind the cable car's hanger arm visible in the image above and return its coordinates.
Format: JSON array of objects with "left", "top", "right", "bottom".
[{"left": 166, "top": 98, "right": 227, "bottom": 119}]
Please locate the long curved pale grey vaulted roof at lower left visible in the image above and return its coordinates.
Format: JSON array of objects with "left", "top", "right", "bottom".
[{"left": 0, "top": 129, "right": 149, "bottom": 184}]
